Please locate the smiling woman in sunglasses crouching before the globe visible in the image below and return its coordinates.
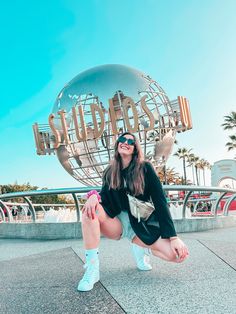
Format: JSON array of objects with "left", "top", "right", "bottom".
[{"left": 78, "top": 132, "right": 188, "bottom": 291}]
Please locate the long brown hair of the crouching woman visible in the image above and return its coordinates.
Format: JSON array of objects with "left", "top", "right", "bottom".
[{"left": 104, "top": 132, "right": 144, "bottom": 195}]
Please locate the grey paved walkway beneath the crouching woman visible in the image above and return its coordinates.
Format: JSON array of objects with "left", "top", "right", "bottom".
[{"left": 0, "top": 227, "right": 236, "bottom": 314}]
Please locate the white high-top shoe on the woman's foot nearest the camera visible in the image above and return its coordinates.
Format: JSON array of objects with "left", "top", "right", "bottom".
[{"left": 77, "top": 259, "right": 100, "bottom": 291}]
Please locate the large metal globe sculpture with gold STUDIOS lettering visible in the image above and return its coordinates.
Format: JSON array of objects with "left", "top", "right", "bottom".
[{"left": 34, "top": 65, "right": 191, "bottom": 186}]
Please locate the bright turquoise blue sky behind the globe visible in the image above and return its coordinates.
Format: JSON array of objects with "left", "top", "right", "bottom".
[{"left": 0, "top": 0, "right": 236, "bottom": 188}]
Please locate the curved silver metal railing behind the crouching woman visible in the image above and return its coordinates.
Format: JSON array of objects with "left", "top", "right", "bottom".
[{"left": 0, "top": 185, "right": 236, "bottom": 223}]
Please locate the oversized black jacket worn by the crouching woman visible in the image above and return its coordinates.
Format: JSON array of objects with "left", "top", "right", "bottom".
[{"left": 100, "top": 161, "right": 176, "bottom": 245}]
